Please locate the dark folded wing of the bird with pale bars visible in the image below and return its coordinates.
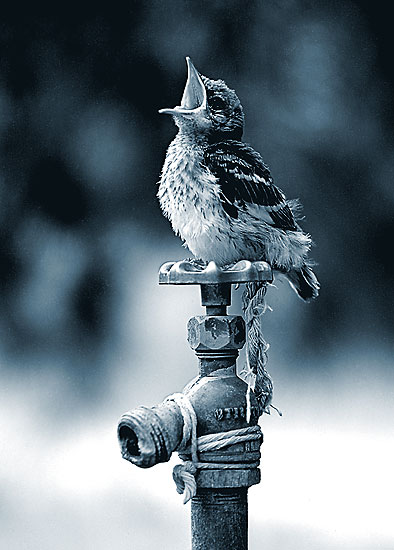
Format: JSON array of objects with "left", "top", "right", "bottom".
[{"left": 205, "top": 140, "right": 297, "bottom": 231}]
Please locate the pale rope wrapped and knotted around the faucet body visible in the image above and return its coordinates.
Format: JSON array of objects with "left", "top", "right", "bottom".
[{"left": 166, "top": 393, "right": 263, "bottom": 504}]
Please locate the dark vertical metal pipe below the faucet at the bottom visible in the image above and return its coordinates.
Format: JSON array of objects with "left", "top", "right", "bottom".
[{"left": 191, "top": 487, "right": 248, "bottom": 550}]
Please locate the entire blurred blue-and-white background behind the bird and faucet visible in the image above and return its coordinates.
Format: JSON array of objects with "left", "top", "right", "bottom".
[{"left": 0, "top": 0, "right": 394, "bottom": 550}]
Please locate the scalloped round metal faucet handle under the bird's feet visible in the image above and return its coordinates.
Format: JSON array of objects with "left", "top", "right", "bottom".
[{"left": 159, "top": 260, "right": 273, "bottom": 285}]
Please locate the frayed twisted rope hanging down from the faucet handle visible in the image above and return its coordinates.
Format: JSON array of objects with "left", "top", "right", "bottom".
[{"left": 241, "top": 283, "right": 281, "bottom": 422}]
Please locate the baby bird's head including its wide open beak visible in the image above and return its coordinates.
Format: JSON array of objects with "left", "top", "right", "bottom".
[{"left": 159, "top": 57, "right": 244, "bottom": 141}]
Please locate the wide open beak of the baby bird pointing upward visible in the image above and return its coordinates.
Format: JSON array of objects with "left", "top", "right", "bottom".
[{"left": 159, "top": 57, "right": 207, "bottom": 116}]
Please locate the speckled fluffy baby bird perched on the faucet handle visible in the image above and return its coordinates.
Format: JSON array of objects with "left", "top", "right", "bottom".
[{"left": 158, "top": 58, "right": 319, "bottom": 300}]
